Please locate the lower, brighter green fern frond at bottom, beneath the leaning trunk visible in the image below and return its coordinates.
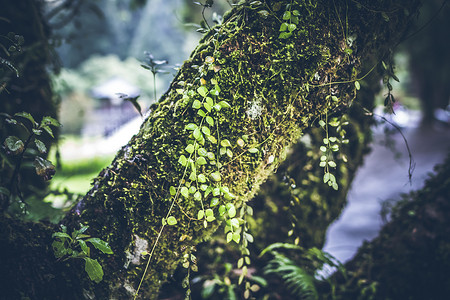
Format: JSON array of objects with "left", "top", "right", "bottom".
[{"left": 264, "top": 252, "right": 318, "bottom": 300}]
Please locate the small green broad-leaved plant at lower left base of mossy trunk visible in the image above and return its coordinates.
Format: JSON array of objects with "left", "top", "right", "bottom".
[{"left": 52, "top": 225, "right": 114, "bottom": 283}]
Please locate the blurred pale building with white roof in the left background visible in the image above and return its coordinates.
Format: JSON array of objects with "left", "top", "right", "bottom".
[{"left": 82, "top": 77, "right": 140, "bottom": 136}]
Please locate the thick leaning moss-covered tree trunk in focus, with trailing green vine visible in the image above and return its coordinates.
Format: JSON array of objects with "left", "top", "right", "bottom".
[{"left": 1, "top": 0, "right": 417, "bottom": 299}]
